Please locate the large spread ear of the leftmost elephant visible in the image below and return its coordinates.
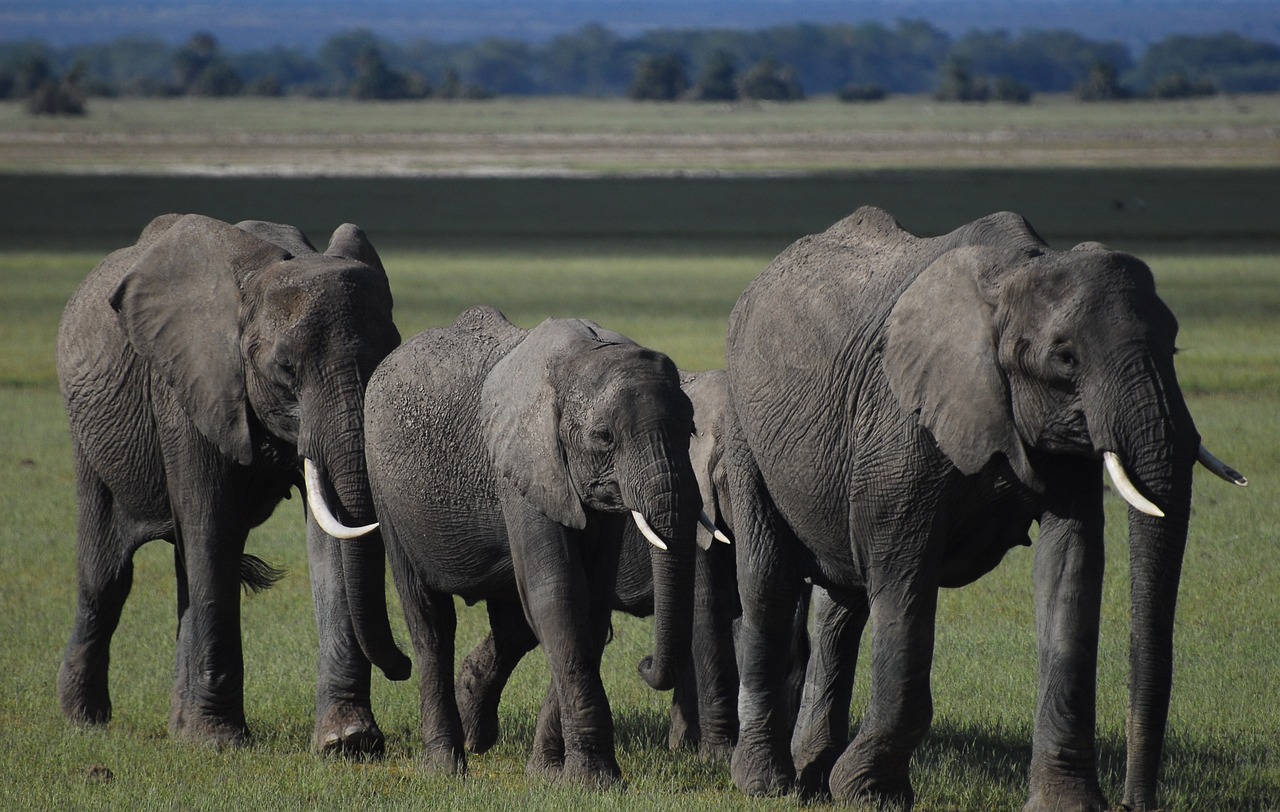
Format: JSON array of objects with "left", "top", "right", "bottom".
[{"left": 109, "top": 214, "right": 289, "bottom": 465}]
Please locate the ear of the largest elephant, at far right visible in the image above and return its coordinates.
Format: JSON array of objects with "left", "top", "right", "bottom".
[{"left": 882, "top": 246, "right": 1042, "bottom": 491}]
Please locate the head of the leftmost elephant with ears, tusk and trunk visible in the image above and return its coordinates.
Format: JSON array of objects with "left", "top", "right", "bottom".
[{"left": 110, "top": 215, "right": 408, "bottom": 672}]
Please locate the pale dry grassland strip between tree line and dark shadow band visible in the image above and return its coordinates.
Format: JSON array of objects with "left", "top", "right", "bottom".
[{"left": 0, "top": 96, "right": 1280, "bottom": 175}]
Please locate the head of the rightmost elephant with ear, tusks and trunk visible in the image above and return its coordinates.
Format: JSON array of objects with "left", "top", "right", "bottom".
[{"left": 883, "top": 215, "right": 1244, "bottom": 808}]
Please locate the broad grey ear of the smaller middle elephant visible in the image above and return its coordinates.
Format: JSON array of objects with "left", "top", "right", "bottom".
[{"left": 480, "top": 319, "right": 625, "bottom": 530}]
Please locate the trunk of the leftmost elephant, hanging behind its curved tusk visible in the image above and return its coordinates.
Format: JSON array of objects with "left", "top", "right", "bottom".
[{"left": 298, "top": 389, "right": 411, "bottom": 680}]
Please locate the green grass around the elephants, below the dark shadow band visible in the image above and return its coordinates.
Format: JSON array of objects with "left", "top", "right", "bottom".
[{"left": 0, "top": 234, "right": 1280, "bottom": 811}]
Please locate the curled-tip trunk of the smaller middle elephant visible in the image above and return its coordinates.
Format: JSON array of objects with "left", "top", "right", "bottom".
[{"left": 622, "top": 430, "right": 701, "bottom": 690}]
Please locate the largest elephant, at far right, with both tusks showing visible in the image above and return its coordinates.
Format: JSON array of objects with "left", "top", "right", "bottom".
[{"left": 726, "top": 206, "right": 1245, "bottom": 811}]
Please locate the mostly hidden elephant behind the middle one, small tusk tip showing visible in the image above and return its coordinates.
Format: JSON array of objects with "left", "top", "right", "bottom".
[{"left": 456, "top": 370, "right": 747, "bottom": 758}]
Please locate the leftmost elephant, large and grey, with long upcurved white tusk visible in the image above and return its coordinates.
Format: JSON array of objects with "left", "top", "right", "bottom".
[{"left": 58, "top": 215, "right": 408, "bottom": 752}]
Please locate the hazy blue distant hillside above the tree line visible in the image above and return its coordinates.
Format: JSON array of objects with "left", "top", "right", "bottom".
[{"left": 0, "top": 0, "right": 1280, "bottom": 51}]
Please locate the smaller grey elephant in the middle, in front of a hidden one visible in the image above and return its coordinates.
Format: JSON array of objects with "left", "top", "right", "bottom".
[{"left": 365, "top": 307, "right": 699, "bottom": 786}]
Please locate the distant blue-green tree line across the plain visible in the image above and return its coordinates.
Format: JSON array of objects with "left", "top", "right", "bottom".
[{"left": 0, "top": 20, "right": 1280, "bottom": 113}]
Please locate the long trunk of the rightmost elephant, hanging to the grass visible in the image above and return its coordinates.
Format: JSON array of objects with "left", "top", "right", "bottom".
[{"left": 1090, "top": 353, "right": 1199, "bottom": 809}]
